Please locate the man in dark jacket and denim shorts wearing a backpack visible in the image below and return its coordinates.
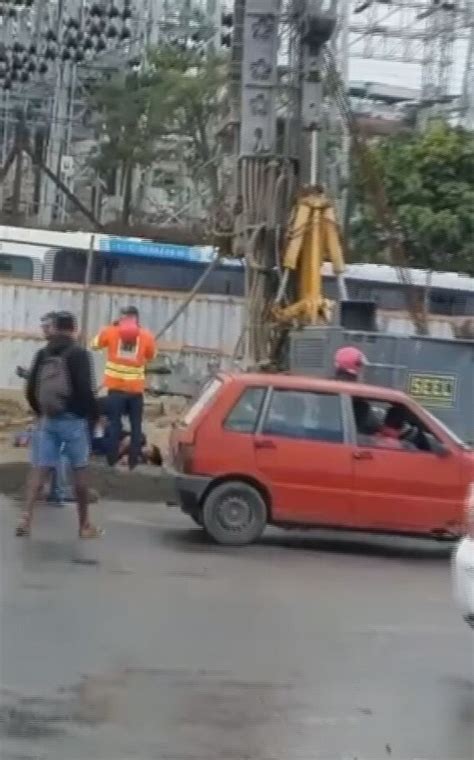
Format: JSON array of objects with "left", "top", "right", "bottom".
[{"left": 17, "top": 312, "right": 102, "bottom": 539}]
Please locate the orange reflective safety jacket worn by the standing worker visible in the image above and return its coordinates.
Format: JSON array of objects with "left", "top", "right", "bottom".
[{"left": 91, "top": 325, "right": 156, "bottom": 393}]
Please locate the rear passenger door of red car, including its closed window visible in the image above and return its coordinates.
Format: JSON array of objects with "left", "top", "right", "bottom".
[{"left": 254, "top": 388, "right": 353, "bottom": 525}]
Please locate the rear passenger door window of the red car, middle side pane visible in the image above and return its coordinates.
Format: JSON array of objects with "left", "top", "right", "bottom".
[{"left": 262, "top": 389, "right": 344, "bottom": 443}]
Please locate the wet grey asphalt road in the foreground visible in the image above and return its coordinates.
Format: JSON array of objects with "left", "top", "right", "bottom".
[{"left": 0, "top": 500, "right": 474, "bottom": 760}]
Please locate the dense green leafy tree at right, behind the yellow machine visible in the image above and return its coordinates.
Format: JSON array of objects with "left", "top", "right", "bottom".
[{"left": 351, "top": 122, "right": 474, "bottom": 274}]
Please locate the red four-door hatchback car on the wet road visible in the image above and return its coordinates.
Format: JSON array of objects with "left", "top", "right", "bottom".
[{"left": 170, "top": 374, "right": 474, "bottom": 545}]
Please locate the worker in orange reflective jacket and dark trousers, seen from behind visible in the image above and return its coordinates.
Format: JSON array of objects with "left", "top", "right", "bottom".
[{"left": 91, "top": 306, "right": 156, "bottom": 470}]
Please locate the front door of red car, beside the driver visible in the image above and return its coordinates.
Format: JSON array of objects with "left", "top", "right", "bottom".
[{"left": 352, "top": 397, "right": 463, "bottom": 533}]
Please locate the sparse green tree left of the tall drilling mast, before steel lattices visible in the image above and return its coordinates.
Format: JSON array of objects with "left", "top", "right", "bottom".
[{"left": 93, "top": 43, "right": 225, "bottom": 224}]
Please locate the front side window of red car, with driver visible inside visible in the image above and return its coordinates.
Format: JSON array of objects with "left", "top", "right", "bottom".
[{"left": 352, "top": 396, "right": 437, "bottom": 452}]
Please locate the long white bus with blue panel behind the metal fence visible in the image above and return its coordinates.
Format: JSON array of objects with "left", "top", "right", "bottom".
[{"left": 0, "top": 225, "right": 474, "bottom": 318}]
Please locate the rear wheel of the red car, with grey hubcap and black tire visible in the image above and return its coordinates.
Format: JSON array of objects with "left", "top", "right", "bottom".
[{"left": 202, "top": 480, "right": 267, "bottom": 546}]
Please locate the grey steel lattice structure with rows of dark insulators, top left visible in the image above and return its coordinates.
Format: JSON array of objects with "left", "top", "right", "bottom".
[{"left": 0, "top": 0, "right": 186, "bottom": 226}]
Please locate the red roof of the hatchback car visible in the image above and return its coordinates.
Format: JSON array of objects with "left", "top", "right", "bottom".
[{"left": 220, "top": 372, "right": 410, "bottom": 403}]
